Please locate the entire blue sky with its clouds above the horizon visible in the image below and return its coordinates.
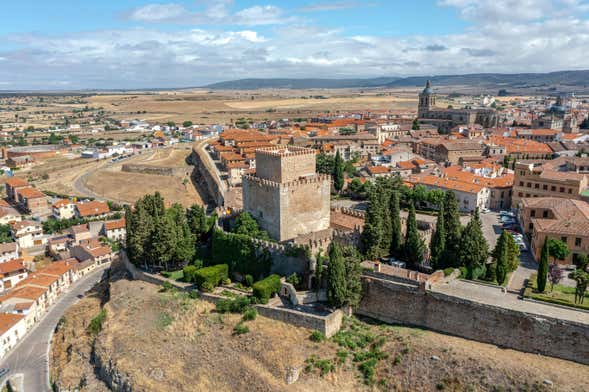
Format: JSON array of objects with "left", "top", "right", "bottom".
[{"left": 0, "top": 0, "right": 589, "bottom": 90}]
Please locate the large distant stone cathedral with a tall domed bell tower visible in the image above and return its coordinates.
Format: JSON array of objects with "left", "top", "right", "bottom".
[{"left": 417, "top": 80, "right": 498, "bottom": 131}]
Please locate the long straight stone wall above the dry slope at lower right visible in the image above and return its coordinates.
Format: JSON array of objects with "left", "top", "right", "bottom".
[{"left": 356, "top": 277, "right": 589, "bottom": 364}]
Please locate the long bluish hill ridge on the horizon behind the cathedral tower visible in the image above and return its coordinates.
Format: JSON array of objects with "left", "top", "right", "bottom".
[{"left": 204, "top": 70, "right": 589, "bottom": 90}]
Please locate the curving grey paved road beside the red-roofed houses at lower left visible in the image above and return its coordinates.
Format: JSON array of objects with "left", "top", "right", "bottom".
[{"left": 0, "top": 265, "right": 108, "bottom": 392}]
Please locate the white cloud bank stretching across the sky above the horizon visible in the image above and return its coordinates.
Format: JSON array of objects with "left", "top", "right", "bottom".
[{"left": 0, "top": 0, "right": 589, "bottom": 88}]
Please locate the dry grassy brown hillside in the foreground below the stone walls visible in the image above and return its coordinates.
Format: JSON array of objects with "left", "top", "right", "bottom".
[{"left": 51, "top": 264, "right": 589, "bottom": 392}]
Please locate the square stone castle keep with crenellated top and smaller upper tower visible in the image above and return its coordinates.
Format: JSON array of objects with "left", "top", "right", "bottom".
[{"left": 242, "top": 146, "right": 331, "bottom": 241}]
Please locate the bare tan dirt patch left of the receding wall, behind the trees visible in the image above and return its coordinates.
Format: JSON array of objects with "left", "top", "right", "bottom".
[{"left": 84, "top": 146, "right": 203, "bottom": 207}]
